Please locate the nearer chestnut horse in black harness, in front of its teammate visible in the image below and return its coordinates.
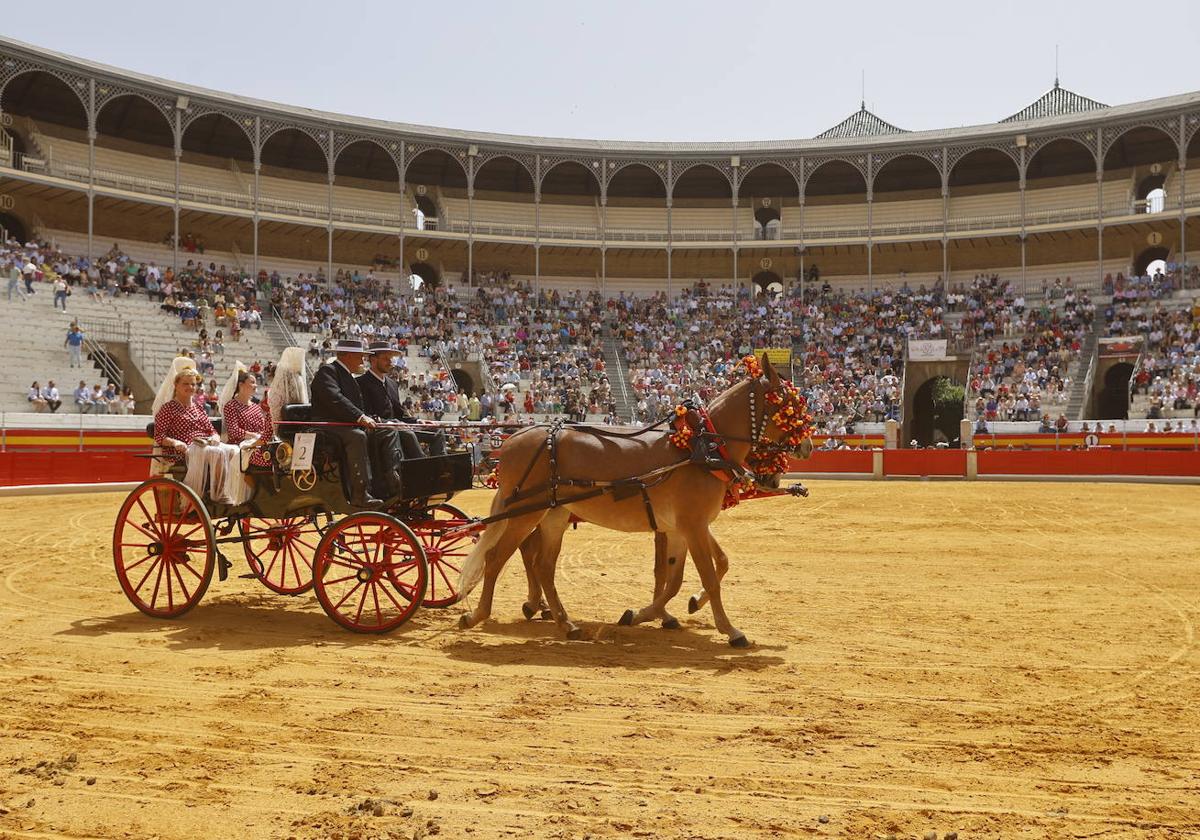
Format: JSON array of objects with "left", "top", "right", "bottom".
[{"left": 460, "top": 355, "right": 803, "bottom": 647}]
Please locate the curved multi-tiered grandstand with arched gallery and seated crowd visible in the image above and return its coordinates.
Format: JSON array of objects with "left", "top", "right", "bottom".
[{"left": 0, "top": 38, "right": 1200, "bottom": 443}]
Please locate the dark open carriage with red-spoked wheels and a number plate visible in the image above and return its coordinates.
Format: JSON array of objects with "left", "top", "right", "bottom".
[{"left": 113, "top": 404, "right": 478, "bottom": 632}]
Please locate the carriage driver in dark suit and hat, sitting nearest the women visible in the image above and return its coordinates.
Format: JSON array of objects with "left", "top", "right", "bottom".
[{"left": 308, "top": 338, "right": 396, "bottom": 509}]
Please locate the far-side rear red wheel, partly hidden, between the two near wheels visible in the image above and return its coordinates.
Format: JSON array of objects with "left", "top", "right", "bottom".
[{"left": 238, "top": 515, "right": 320, "bottom": 595}]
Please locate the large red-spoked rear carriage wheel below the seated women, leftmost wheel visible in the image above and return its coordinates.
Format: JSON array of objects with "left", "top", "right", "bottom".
[{"left": 113, "top": 478, "right": 216, "bottom": 618}]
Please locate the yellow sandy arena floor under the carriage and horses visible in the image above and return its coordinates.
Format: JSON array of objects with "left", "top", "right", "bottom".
[{"left": 0, "top": 481, "right": 1200, "bottom": 840}]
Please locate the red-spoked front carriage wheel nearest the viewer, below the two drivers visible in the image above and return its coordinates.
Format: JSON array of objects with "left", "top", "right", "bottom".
[{"left": 312, "top": 512, "right": 430, "bottom": 632}]
